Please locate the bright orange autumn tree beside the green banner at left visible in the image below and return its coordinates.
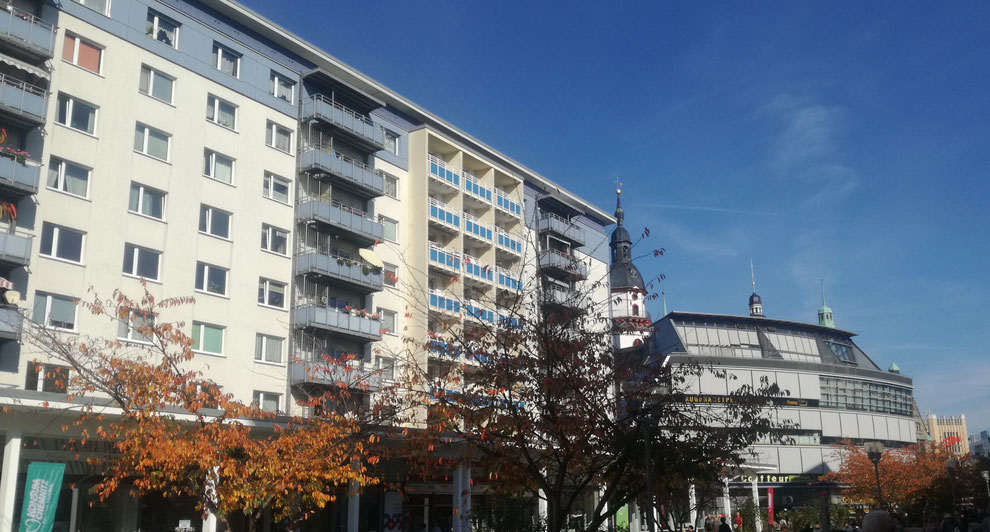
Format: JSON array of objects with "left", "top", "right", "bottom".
[{"left": 31, "top": 290, "right": 384, "bottom": 530}]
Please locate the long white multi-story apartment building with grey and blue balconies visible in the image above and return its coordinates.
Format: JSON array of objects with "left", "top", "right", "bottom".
[{"left": 0, "top": 0, "right": 613, "bottom": 532}]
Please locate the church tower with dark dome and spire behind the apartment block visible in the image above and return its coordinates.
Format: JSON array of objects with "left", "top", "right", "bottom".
[{"left": 609, "top": 187, "right": 651, "bottom": 349}]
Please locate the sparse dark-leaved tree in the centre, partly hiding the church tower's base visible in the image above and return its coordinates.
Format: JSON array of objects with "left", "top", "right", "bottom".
[{"left": 376, "top": 219, "right": 779, "bottom": 532}]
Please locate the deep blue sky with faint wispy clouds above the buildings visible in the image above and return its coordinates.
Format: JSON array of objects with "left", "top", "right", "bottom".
[{"left": 247, "top": 0, "right": 990, "bottom": 433}]
